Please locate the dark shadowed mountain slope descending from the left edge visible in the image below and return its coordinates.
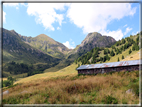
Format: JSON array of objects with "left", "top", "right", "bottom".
[{"left": 2, "top": 29, "right": 60, "bottom": 64}]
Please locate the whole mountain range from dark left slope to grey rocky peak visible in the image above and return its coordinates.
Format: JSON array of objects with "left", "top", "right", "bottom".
[{"left": 3, "top": 29, "right": 116, "bottom": 74}]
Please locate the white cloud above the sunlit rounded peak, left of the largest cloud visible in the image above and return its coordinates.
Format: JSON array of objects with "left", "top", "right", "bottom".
[{"left": 27, "top": 3, "right": 67, "bottom": 31}]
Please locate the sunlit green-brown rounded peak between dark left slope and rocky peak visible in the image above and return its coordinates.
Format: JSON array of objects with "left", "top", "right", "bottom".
[{"left": 20, "top": 34, "right": 70, "bottom": 58}]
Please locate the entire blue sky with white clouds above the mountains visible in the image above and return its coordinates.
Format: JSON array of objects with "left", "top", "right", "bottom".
[{"left": 2, "top": 3, "right": 140, "bottom": 49}]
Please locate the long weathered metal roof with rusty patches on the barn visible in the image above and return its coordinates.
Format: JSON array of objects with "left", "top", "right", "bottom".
[{"left": 77, "top": 60, "right": 142, "bottom": 70}]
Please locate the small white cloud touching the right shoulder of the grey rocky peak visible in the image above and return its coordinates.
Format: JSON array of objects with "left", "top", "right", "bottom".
[{"left": 102, "top": 29, "right": 124, "bottom": 41}]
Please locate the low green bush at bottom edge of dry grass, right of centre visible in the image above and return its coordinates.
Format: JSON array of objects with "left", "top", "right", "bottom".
[{"left": 102, "top": 95, "right": 118, "bottom": 104}]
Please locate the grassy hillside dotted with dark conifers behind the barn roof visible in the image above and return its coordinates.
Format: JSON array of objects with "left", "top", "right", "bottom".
[{"left": 75, "top": 34, "right": 139, "bottom": 64}]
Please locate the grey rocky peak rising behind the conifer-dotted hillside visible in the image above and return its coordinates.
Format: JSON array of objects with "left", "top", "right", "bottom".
[{"left": 46, "top": 32, "right": 116, "bottom": 72}]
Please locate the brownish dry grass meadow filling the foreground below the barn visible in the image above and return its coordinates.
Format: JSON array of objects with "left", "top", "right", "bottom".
[{"left": 3, "top": 72, "right": 139, "bottom": 104}]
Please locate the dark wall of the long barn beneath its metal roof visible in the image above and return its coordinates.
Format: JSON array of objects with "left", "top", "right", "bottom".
[{"left": 78, "top": 65, "right": 139, "bottom": 74}]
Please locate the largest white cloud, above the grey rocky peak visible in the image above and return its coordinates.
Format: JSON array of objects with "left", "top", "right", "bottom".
[{"left": 67, "top": 3, "right": 136, "bottom": 33}]
